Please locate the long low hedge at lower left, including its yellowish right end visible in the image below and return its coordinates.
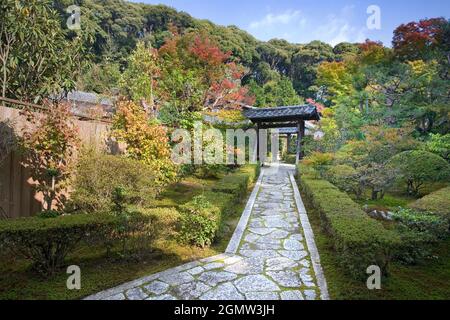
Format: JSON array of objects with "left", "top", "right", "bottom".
[{"left": 0, "top": 209, "right": 178, "bottom": 276}]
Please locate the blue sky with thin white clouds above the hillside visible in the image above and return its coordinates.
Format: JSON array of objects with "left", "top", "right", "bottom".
[{"left": 128, "top": 0, "right": 450, "bottom": 46}]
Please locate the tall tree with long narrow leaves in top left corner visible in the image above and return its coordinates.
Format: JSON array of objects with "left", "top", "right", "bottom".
[{"left": 0, "top": 0, "right": 82, "bottom": 102}]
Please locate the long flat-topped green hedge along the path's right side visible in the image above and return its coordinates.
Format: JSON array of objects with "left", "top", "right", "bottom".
[{"left": 300, "top": 166, "right": 400, "bottom": 279}]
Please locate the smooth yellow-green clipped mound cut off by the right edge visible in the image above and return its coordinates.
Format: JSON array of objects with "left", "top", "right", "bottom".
[{"left": 408, "top": 187, "right": 450, "bottom": 221}]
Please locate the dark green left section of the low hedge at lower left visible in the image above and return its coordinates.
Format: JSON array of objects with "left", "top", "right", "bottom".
[{"left": 0, "top": 214, "right": 117, "bottom": 275}]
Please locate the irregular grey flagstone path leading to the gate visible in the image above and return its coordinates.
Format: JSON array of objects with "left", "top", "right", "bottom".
[{"left": 87, "top": 165, "right": 328, "bottom": 300}]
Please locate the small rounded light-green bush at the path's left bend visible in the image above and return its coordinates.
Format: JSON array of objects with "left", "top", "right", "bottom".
[{"left": 180, "top": 196, "right": 220, "bottom": 248}]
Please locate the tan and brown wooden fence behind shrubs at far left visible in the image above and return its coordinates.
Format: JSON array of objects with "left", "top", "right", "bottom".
[{"left": 0, "top": 105, "right": 118, "bottom": 218}]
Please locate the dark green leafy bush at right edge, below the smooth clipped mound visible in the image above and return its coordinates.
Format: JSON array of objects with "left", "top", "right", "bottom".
[{"left": 393, "top": 208, "right": 449, "bottom": 264}]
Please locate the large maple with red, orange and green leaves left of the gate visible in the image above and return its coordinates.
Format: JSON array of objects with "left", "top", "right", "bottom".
[{"left": 158, "top": 32, "right": 254, "bottom": 125}]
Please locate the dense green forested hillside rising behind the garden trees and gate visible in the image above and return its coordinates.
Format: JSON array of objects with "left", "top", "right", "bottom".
[{"left": 52, "top": 0, "right": 346, "bottom": 105}]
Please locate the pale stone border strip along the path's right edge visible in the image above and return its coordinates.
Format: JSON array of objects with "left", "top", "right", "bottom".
[{"left": 289, "top": 172, "right": 330, "bottom": 300}]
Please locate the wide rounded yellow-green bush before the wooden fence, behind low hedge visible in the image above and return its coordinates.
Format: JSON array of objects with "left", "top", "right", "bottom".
[{"left": 69, "top": 154, "right": 156, "bottom": 212}]
